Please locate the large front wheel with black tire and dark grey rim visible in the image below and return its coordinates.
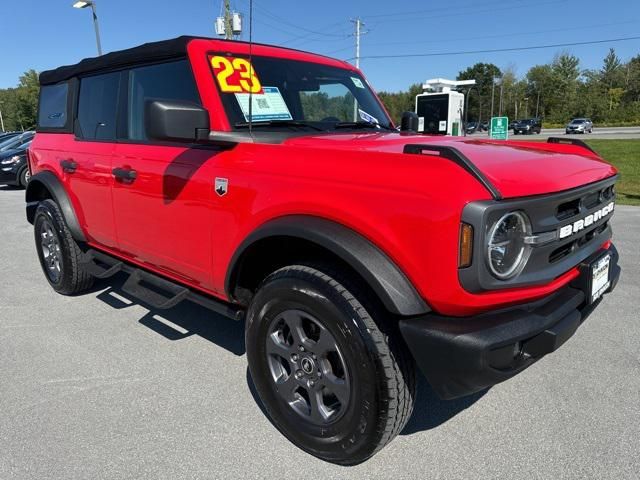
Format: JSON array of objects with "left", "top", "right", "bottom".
[{"left": 245, "top": 265, "right": 415, "bottom": 465}]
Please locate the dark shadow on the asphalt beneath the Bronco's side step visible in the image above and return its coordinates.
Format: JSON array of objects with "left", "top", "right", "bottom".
[{"left": 92, "top": 274, "right": 245, "bottom": 356}]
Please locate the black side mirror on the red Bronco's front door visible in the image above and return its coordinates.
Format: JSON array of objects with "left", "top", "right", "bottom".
[{"left": 144, "top": 100, "right": 210, "bottom": 142}]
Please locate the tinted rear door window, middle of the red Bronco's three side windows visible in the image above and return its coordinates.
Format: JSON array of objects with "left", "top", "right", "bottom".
[{"left": 76, "top": 72, "right": 120, "bottom": 140}]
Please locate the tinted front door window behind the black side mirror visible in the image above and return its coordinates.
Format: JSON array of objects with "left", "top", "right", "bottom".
[{"left": 127, "top": 60, "right": 200, "bottom": 141}]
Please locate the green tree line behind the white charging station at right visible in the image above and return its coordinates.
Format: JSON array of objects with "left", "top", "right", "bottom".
[{"left": 379, "top": 48, "right": 640, "bottom": 126}]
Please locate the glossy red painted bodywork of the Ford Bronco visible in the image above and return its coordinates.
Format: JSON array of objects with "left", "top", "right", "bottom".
[{"left": 31, "top": 40, "right": 615, "bottom": 316}]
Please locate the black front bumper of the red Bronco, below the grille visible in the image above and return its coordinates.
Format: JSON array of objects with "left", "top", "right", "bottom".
[{"left": 400, "top": 245, "right": 621, "bottom": 399}]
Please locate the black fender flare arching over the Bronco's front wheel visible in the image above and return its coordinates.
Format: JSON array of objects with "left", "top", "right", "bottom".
[{"left": 225, "top": 215, "right": 430, "bottom": 316}]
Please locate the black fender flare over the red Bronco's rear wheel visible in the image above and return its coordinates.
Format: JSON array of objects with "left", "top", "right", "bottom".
[{"left": 25, "top": 171, "right": 87, "bottom": 242}]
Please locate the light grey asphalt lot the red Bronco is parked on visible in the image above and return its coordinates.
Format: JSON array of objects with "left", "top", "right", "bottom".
[{"left": 0, "top": 187, "right": 640, "bottom": 480}]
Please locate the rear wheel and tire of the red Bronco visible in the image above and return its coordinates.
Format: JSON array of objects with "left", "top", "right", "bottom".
[{"left": 33, "top": 200, "right": 94, "bottom": 295}]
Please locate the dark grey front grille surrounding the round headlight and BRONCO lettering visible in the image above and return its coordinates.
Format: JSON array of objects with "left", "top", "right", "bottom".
[{"left": 459, "top": 176, "right": 617, "bottom": 292}]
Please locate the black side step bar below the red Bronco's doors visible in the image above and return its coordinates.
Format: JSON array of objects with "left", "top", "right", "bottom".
[{"left": 81, "top": 249, "right": 244, "bottom": 320}]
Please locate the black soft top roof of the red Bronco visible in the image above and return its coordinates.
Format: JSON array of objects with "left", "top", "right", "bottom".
[{"left": 40, "top": 36, "right": 198, "bottom": 85}]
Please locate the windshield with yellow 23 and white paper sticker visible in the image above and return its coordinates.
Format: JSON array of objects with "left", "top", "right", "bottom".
[{"left": 209, "top": 55, "right": 391, "bottom": 130}]
